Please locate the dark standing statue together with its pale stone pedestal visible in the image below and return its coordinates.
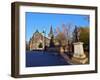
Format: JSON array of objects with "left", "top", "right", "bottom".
[{"left": 72, "top": 27, "right": 88, "bottom": 64}]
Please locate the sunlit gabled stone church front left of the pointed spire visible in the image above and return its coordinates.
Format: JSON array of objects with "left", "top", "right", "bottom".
[{"left": 29, "top": 30, "right": 50, "bottom": 50}]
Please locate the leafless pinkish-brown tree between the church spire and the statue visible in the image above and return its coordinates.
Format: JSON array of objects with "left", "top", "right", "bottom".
[{"left": 55, "top": 24, "right": 73, "bottom": 52}]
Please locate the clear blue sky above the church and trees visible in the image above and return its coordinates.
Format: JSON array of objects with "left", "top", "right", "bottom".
[{"left": 25, "top": 12, "right": 89, "bottom": 41}]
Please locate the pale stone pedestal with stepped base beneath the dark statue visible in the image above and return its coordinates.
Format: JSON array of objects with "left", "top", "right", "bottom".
[{"left": 72, "top": 42, "right": 88, "bottom": 64}]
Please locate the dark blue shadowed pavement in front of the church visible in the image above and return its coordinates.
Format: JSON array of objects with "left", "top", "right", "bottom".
[{"left": 26, "top": 51, "right": 69, "bottom": 67}]
